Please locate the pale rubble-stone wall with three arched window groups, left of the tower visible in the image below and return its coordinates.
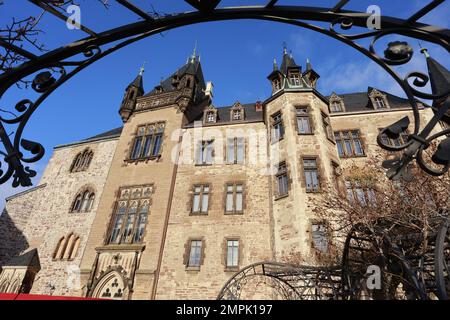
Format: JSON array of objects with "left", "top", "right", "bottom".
[{"left": 0, "top": 138, "right": 117, "bottom": 295}]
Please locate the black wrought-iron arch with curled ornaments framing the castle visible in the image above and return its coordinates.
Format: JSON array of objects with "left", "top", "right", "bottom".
[{"left": 0, "top": 0, "right": 450, "bottom": 187}]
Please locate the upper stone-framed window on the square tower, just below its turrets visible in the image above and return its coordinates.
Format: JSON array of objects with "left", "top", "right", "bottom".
[{"left": 131, "top": 122, "right": 165, "bottom": 160}]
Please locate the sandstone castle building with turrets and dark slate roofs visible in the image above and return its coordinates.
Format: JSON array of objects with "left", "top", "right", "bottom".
[{"left": 0, "top": 50, "right": 442, "bottom": 299}]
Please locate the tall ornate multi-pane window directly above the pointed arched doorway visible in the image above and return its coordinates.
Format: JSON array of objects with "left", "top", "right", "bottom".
[{"left": 107, "top": 185, "right": 153, "bottom": 244}]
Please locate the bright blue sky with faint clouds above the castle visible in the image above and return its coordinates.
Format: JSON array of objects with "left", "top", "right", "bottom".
[{"left": 0, "top": 0, "right": 450, "bottom": 208}]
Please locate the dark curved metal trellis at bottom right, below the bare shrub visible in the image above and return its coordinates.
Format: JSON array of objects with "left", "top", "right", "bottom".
[{"left": 217, "top": 217, "right": 450, "bottom": 300}]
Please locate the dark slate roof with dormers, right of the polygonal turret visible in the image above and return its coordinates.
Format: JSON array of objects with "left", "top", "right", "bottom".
[{"left": 326, "top": 87, "right": 420, "bottom": 113}]
